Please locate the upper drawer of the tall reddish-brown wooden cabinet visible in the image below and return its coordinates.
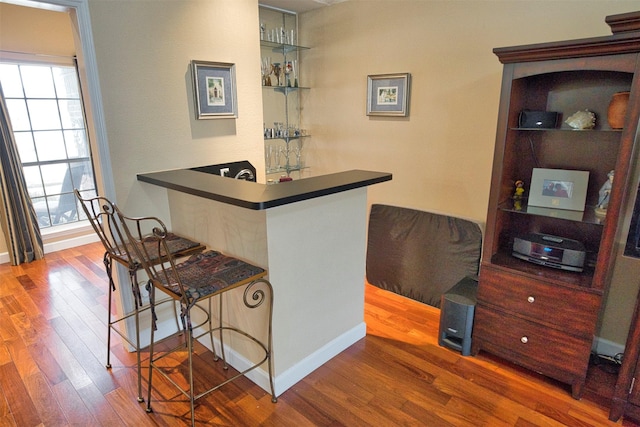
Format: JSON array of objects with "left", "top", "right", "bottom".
[{"left": 478, "top": 268, "right": 601, "bottom": 339}]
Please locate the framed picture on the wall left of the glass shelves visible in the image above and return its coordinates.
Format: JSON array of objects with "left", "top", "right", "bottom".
[{"left": 191, "top": 60, "right": 238, "bottom": 119}]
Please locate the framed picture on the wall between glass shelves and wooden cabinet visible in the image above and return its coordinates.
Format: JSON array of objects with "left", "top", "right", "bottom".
[{"left": 367, "top": 73, "right": 411, "bottom": 117}]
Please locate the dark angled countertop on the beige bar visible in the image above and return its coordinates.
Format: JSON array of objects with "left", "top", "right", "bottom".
[{"left": 138, "top": 169, "right": 392, "bottom": 210}]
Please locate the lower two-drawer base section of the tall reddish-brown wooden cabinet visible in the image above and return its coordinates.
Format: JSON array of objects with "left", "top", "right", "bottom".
[{"left": 472, "top": 264, "right": 601, "bottom": 396}]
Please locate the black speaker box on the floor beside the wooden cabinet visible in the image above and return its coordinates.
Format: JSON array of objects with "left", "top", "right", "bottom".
[{"left": 438, "top": 277, "right": 478, "bottom": 356}]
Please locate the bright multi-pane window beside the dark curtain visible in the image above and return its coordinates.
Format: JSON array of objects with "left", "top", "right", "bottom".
[{"left": 0, "top": 62, "right": 96, "bottom": 228}]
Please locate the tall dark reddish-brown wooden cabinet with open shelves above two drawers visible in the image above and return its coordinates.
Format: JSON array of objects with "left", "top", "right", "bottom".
[{"left": 472, "top": 10, "right": 640, "bottom": 398}]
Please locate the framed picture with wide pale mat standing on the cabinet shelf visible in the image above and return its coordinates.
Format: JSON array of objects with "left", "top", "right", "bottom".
[{"left": 529, "top": 168, "right": 589, "bottom": 211}]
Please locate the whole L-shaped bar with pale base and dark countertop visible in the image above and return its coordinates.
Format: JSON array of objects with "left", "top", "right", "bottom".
[{"left": 138, "top": 169, "right": 392, "bottom": 395}]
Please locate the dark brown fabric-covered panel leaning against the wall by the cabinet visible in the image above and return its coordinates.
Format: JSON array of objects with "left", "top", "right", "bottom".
[{"left": 366, "top": 204, "right": 482, "bottom": 307}]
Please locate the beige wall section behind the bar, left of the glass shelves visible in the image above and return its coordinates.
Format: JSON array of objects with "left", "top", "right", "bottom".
[{"left": 89, "top": 0, "right": 264, "bottom": 220}]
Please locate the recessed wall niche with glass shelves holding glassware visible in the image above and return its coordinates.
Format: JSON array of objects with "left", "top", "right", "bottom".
[{"left": 260, "top": 5, "right": 309, "bottom": 182}]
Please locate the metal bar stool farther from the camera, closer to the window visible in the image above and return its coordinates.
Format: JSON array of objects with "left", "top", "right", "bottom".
[{"left": 74, "top": 189, "right": 205, "bottom": 402}]
